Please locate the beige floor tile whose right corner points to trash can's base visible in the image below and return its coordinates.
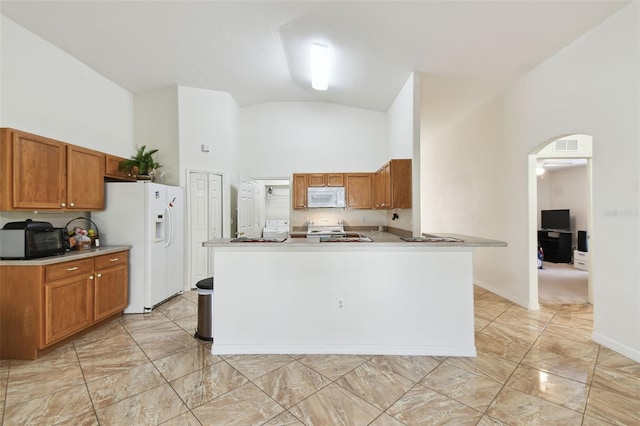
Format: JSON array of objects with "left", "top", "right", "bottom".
[{"left": 131, "top": 322, "right": 199, "bottom": 361}]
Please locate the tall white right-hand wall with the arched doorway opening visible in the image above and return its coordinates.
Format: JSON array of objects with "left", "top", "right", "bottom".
[{"left": 422, "top": 2, "right": 640, "bottom": 361}]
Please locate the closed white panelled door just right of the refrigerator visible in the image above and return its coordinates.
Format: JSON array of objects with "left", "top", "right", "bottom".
[{"left": 185, "top": 172, "right": 222, "bottom": 289}]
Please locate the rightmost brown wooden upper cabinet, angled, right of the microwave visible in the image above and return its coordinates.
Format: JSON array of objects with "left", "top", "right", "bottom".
[{"left": 373, "top": 159, "right": 411, "bottom": 209}]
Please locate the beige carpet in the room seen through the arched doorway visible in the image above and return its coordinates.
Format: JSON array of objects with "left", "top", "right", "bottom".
[{"left": 538, "top": 262, "right": 589, "bottom": 304}]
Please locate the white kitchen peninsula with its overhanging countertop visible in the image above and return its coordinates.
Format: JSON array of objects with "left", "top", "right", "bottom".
[{"left": 203, "top": 231, "right": 506, "bottom": 356}]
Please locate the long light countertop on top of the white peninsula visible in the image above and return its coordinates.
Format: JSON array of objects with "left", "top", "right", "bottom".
[{"left": 202, "top": 231, "right": 507, "bottom": 249}]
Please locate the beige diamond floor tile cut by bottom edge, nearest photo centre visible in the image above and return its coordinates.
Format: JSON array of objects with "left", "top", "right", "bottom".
[{"left": 289, "top": 383, "right": 382, "bottom": 426}]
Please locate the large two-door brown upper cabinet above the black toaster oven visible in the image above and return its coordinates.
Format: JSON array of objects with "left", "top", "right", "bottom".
[{"left": 0, "top": 128, "right": 105, "bottom": 211}]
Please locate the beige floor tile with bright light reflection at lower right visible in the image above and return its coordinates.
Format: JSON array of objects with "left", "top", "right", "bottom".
[{"left": 507, "top": 366, "right": 589, "bottom": 413}]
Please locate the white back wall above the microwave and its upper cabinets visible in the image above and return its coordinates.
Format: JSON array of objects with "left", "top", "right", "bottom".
[{"left": 237, "top": 102, "right": 389, "bottom": 178}]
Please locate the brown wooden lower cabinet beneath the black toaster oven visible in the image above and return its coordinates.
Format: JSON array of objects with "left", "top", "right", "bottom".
[{"left": 0, "top": 250, "right": 129, "bottom": 359}]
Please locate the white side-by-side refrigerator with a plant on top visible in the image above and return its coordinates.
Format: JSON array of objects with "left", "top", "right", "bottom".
[{"left": 91, "top": 181, "right": 184, "bottom": 313}]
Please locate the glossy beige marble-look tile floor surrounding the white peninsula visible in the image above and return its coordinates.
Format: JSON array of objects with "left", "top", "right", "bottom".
[{"left": 0, "top": 288, "right": 640, "bottom": 426}]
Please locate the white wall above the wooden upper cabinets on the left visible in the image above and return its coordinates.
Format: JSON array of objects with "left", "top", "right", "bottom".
[{"left": 0, "top": 16, "right": 133, "bottom": 157}]
